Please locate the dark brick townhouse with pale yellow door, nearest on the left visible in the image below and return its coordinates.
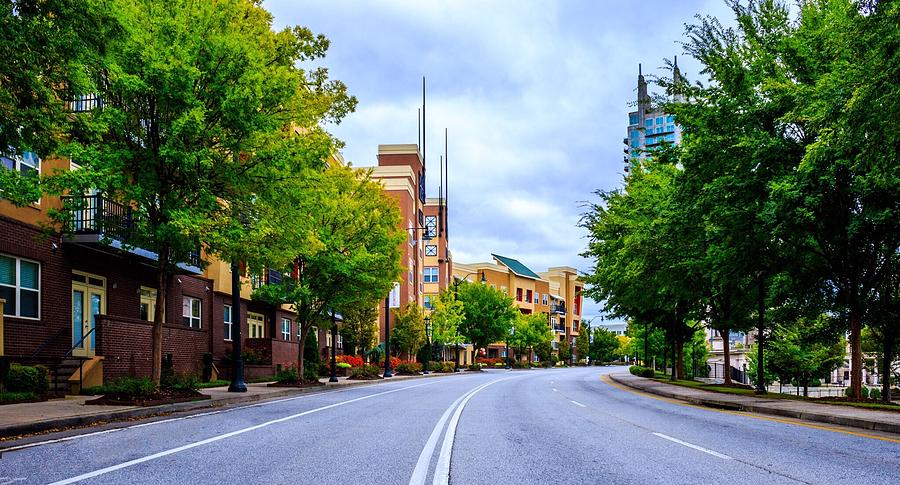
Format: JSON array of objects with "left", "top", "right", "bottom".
[{"left": 0, "top": 154, "right": 213, "bottom": 392}]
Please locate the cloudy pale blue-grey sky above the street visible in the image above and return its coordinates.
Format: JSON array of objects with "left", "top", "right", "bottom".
[{"left": 265, "top": 0, "right": 729, "bottom": 315}]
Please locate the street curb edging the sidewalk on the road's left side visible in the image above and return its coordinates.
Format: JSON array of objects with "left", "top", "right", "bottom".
[{"left": 0, "top": 372, "right": 465, "bottom": 438}]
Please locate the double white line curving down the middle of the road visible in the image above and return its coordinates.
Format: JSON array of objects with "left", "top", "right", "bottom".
[{"left": 409, "top": 376, "right": 519, "bottom": 485}]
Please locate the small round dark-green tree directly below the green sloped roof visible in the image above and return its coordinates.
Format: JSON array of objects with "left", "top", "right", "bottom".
[{"left": 457, "top": 281, "right": 519, "bottom": 352}]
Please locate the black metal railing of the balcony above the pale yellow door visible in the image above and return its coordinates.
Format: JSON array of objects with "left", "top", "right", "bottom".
[{"left": 62, "top": 194, "right": 200, "bottom": 268}]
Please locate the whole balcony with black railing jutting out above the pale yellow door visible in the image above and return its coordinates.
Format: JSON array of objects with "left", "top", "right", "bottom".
[{"left": 62, "top": 194, "right": 202, "bottom": 274}]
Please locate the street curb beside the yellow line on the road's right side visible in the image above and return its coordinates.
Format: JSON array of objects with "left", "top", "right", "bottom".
[{"left": 608, "top": 374, "right": 900, "bottom": 434}]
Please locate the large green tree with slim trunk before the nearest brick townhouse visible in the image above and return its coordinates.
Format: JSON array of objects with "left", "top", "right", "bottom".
[{"left": 18, "top": 0, "right": 355, "bottom": 382}]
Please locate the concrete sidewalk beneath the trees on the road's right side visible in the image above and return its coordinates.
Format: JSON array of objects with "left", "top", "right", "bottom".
[{"left": 609, "top": 373, "right": 900, "bottom": 434}]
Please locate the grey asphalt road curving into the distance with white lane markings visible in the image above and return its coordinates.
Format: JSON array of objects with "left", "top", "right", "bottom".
[{"left": 0, "top": 367, "right": 900, "bottom": 484}]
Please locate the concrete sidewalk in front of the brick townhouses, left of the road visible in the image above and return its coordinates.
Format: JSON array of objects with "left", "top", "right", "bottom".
[{"left": 0, "top": 373, "right": 463, "bottom": 441}]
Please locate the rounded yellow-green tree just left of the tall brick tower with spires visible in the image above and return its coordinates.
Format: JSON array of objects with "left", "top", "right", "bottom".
[{"left": 253, "top": 163, "right": 406, "bottom": 374}]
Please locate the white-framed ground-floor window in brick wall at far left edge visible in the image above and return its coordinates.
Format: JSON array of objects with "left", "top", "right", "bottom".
[{"left": 0, "top": 255, "right": 41, "bottom": 318}]
